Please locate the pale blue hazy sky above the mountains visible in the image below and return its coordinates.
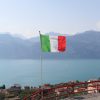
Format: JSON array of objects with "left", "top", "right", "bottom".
[{"left": 0, "top": 0, "right": 100, "bottom": 38}]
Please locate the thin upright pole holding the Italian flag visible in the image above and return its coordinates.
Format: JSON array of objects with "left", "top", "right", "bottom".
[{"left": 39, "top": 31, "right": 43, "bottom": 100}]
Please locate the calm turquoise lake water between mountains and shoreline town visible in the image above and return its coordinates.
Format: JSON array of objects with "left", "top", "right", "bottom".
[{"left": 0, "top": 60, "right": 100, "bottom": 86}]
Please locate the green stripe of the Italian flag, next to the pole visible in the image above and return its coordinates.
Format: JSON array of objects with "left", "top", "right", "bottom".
[{"left": 40, "top": 35, "right": 50, "bottom": 52}]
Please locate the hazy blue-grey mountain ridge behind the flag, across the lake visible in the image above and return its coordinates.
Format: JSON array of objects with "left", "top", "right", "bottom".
[{"left": 0, "top": 31, "right": 100, "bottom": 59}]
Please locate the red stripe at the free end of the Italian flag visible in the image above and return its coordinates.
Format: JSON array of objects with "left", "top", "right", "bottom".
[{"left": 58, "top": 36, "right": 66, "bottom": 52}]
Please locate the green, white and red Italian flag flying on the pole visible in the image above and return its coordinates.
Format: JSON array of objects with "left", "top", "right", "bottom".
[{"left": 40, "top": 35, "right": 66, "bottom": 52}]
